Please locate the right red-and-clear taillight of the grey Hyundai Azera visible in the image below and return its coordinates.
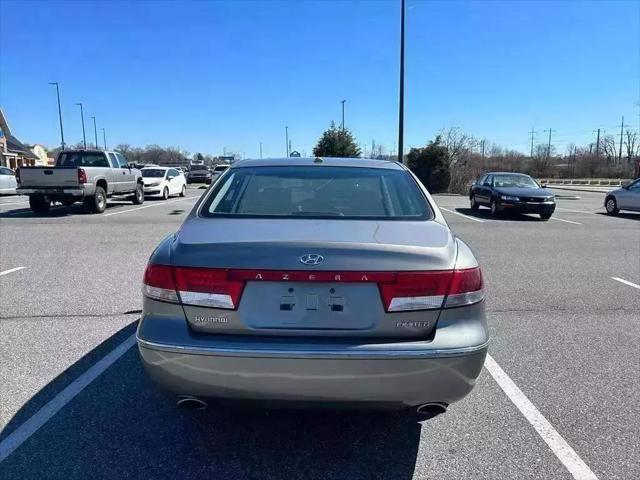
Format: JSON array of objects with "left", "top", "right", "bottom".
[{"left": 380, "top": 267, "right": 484, "bottom": 312}]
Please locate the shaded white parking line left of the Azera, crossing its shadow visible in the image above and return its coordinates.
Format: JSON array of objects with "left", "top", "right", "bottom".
[{"left": 0, "top": 334, "right": 136, "bottom": 462}]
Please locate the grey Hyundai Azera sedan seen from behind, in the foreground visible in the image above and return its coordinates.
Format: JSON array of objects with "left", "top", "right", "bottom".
[{"left": 137, "top": 158, "right": 488, "bottom": 412}]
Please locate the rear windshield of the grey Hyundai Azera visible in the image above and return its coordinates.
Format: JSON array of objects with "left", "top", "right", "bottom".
[{"left": 201, "top": 166, "right": 433, "bottom": 220}]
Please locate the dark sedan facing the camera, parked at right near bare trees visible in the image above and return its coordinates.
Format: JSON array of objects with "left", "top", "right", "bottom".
[{"left": 469, "top": 172, "right": 556, "bottom": 220}]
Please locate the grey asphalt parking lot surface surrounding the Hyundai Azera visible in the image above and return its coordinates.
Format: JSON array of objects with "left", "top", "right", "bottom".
[{"left": 0, "top": 186, "right": 640, "bottom": 479}]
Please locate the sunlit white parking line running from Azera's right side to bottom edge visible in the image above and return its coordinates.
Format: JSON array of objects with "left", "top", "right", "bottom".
[{"left": 484, "top": 355, "right": 598, "bottom": 480}]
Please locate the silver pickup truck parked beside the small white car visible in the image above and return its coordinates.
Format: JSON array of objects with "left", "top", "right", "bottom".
[{"left": 16, "top": 150, "right": 144, "bottom": 213}]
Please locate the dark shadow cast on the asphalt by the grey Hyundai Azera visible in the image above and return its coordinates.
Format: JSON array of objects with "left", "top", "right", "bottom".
[{"left": 0, "top": 324, "right": 421, "bottom": 480}]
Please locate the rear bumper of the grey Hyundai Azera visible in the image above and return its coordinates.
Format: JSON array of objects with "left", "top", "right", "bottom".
[{"left": 137, "top": 304, "right": 488, "bottom": 408}]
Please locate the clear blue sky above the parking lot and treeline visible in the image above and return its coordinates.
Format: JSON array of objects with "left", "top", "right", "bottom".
[{"left": 0, "top": 0, "right": 640, "bottom": 157}]
